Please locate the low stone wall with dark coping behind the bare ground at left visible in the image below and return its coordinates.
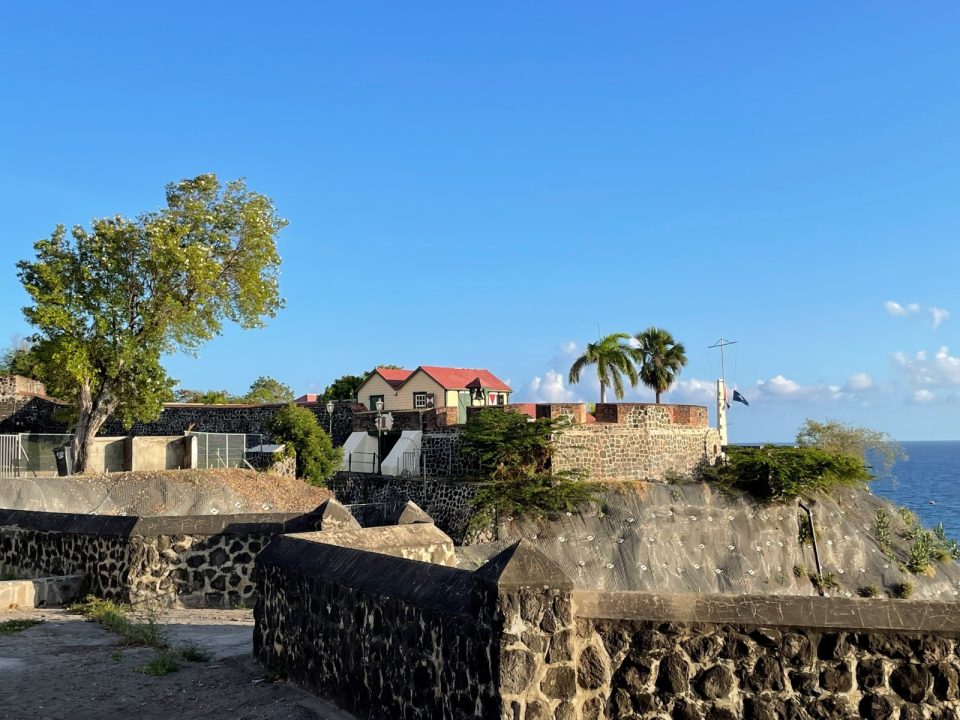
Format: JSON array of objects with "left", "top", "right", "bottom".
[{"left": 0, "top": 510, "right": 326, "bottom": 607}]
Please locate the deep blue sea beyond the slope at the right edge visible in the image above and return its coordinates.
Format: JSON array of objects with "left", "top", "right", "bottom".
[{"left": 870, "top": 441, "right": 960, "bottom": 540}]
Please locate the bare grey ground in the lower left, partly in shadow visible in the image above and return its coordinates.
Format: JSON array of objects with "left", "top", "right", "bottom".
[{"left": 0, "top": 610, "right": 353, "bottom": 720}]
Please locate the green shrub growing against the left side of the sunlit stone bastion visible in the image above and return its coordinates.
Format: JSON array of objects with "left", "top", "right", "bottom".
[{"left": 463, "top": 409, "right": 597, "bottom": 523}]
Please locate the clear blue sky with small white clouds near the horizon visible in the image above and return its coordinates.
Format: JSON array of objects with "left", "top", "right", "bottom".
[{"left": 0, "top": 2, "right": 960, "bottom": 441}]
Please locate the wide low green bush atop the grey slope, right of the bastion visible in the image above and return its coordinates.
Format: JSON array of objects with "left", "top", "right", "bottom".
[{"left": 703, "top": 447, "right": 873, "bottom": 500}]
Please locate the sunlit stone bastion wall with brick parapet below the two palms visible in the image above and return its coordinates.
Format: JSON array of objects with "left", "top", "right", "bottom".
[{"left": 553, "top": 403, "right": 720, "bottom": 480}]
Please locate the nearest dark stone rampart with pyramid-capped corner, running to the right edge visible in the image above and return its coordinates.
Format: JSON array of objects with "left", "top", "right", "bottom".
[{"left": 254, "top": 537, "right": 960, "bottom": 720}]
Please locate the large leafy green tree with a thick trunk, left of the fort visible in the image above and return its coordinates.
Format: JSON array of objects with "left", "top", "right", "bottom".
[{"left": 17, "top": 174, "right": 286, "bottom": 471}]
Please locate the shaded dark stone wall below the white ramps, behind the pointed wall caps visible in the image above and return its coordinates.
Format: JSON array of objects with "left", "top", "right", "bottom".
[{"left": 327, "top": 472, "right": 481, "bottom": 544}]
